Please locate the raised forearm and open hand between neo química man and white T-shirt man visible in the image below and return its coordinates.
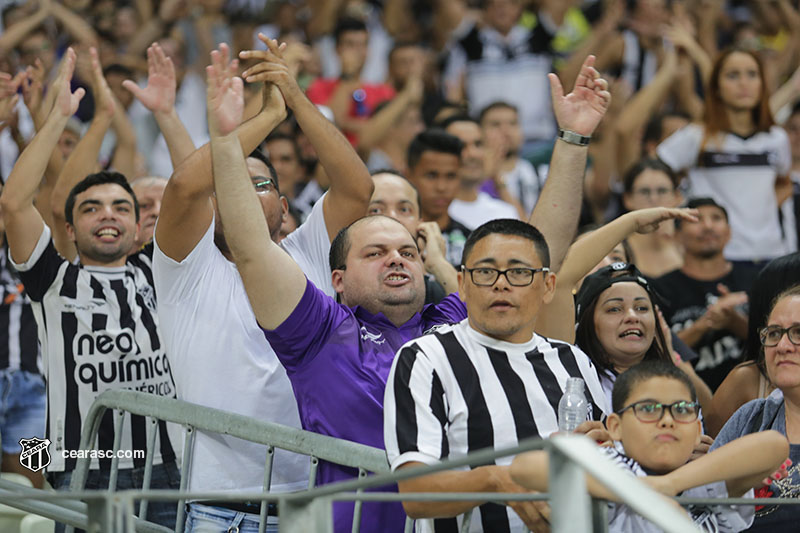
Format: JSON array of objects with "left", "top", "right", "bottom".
[{"left": 122, "top": 43, "right": 195, "bottom": 168}]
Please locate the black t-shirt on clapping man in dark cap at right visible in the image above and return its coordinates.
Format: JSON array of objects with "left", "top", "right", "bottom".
[{"left": 653, "top": 264, "right": 756, "bottom": 391}]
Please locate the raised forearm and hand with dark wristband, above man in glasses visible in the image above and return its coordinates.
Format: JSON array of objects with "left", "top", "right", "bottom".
[{"left": 530, "top": 56, "right": 611, "bottom": 272}]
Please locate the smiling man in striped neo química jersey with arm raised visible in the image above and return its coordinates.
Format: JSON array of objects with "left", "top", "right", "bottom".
[{"left": 0, "top": 48, "right": 180, "bottom": 527}]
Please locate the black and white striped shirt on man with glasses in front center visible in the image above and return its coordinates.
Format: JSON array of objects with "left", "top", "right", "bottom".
[{"left": 384, "top": 319, "right": 609, "bottom": 532}]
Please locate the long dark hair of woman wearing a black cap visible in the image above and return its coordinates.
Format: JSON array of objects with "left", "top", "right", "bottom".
[{"left": 575, "top": 267, "right": 672, "bottom": 374}]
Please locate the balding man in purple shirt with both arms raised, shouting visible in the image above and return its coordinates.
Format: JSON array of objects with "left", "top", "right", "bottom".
[{"left": 208, "top": 41, "right": 608, "bottom": 531}]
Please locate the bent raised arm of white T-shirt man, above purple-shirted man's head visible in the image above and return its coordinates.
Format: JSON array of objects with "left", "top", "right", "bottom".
[{"left": 240, "top": 34, "right": 374, "bottom": 240}]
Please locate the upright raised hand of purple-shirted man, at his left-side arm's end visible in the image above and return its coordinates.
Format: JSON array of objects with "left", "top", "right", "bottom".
[{"left": 206, "top": 43, "right": 244, "bottom": 137}]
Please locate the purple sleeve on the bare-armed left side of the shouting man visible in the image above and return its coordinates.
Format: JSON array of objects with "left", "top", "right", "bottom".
[{"left": 263, "top": 281, "right": 351, "bottom": 374}]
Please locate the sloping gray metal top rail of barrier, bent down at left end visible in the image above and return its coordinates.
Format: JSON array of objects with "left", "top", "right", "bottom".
[{"left": 81, "top": 390, "right": 389, "bottom": 473}]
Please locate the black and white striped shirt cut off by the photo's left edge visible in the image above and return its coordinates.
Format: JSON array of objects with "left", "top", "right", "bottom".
[{"left": 0, "top": 246, "right": 42, "bottom": 374}]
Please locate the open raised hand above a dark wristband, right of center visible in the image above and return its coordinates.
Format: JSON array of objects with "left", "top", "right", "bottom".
[{"left": 547, "top": 55, "right": 611, "bottom": 136}]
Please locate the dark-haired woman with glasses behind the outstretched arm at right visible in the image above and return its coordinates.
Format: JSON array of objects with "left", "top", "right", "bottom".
[{"left": 622, "top": 158, "right": 683, "bottom": 278}]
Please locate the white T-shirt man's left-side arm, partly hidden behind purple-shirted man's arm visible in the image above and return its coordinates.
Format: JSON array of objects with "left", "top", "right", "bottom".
[{"left": 155, "top": 50, "right": 286, "bottom": 261}]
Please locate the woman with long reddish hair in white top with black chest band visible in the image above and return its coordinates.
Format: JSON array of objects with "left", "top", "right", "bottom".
[{"left": 657, "top": 48, "right": 791, "bottom": 261}]
